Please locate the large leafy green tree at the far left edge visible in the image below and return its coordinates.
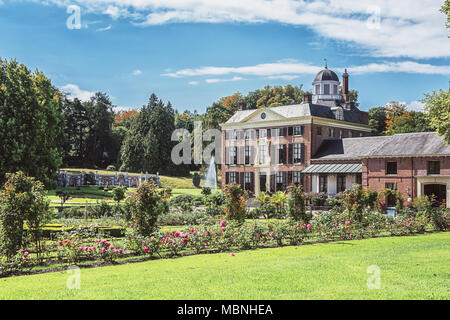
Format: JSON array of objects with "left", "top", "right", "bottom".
[{"left": 0, "top": 58, "right": 63, "bottom": 186}]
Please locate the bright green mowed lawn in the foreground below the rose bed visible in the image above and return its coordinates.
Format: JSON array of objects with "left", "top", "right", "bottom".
[{"left": 0, "top": 232, "right": 450, "bottom": 300}]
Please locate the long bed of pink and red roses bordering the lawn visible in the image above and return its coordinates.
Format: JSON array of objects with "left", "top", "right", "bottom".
[{"left": 0, "top": 211, "right": 450, "bottom": 276}]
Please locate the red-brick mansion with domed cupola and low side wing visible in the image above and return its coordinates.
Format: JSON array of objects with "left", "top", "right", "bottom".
[{"left": 221, "top": 67, "right": 450, "bottom": 206}]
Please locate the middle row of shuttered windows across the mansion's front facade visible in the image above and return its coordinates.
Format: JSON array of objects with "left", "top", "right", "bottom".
[{"left": 227, "top": 143, "right": 305, "bottom": 165}]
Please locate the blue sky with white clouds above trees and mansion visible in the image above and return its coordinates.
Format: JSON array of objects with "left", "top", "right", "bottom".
[{"left": 0, "top": 0, "right": 450, "bottom": 112}]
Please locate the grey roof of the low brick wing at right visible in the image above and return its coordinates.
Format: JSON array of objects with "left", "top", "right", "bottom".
[{"left": 313, "top": 132, "right": 450, "bottom": 160}]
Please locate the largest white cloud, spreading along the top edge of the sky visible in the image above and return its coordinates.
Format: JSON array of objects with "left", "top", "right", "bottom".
[{"left": 33, "top": 0, "right": 450, "bottom": 58}]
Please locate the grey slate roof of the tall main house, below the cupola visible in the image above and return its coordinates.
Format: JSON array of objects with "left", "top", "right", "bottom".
[{"left": 226, "top": 102, "right": 365, "bottom": 124}]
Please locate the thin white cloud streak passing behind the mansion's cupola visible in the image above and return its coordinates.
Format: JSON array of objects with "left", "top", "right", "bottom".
[{"left": 162, "top": 59, "right": 450, "bottom": 79}]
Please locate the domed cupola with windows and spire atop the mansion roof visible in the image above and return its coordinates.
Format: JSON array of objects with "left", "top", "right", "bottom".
[{"left": 312, "top": 60, "right": 342, "bottom": 103}]
